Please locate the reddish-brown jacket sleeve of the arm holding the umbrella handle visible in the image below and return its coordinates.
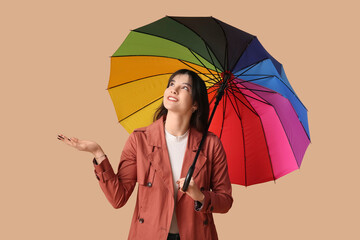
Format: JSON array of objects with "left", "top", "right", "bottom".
[{"left": 195, "top": 137, "right": 233, "bottom": 213}]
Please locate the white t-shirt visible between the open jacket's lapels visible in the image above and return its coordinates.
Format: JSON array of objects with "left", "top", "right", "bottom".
[{"left": 165, "top": 129, "right": 189, "bottom": 233}]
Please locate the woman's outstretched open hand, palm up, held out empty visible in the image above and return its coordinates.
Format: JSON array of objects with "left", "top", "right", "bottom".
[{"left": 58, "top": 134, "right": 103, "bottom": 157}]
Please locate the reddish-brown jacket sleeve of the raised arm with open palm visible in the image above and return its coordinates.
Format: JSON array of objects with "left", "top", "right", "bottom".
[{"left": 94, "top": 133, "right": 137, "bottom": 208}]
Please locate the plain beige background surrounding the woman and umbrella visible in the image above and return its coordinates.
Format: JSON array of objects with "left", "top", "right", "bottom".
[{"left": 0, "top": 0, "right": 360, "bottom": 240}]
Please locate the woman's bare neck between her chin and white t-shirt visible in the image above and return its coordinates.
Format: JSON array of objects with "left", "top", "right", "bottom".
[{"left": 165, "top": 112, "right": 191, "bottom": 136}]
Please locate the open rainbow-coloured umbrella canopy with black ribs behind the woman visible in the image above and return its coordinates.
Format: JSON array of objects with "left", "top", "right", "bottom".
[{"left": 108, "top": 16, "right": 310, "bottom": 186}]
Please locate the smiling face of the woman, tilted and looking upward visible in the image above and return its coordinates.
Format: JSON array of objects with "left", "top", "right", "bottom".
[{"left": 163, "top": 74, "right": 197, "bottom": 116}]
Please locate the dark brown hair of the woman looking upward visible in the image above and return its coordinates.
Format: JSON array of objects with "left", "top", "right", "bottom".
[{"left": 153, "top": 69, "right": 209, "bottom": 133}]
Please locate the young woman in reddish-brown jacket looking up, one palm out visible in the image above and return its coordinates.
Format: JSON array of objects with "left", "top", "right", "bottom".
[{"left": 58, "top": 69, "right": 233, "bottom": 240}]
